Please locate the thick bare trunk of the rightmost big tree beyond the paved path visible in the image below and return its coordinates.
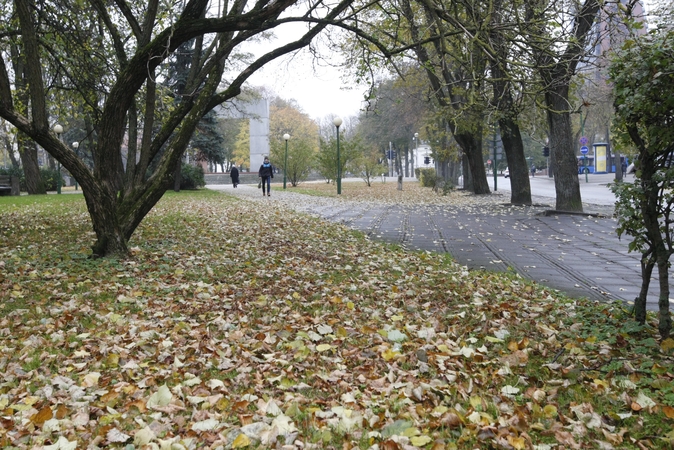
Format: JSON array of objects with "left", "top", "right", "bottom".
[{"left": 545, "top": 89, "right": 583, "bottom": 212}]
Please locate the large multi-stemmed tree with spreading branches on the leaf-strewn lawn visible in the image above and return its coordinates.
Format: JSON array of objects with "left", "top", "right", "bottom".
[{"left": 0, "top": 0, "right": 351, "bottom": 256}]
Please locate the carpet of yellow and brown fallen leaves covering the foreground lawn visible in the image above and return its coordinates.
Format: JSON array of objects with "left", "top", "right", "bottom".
[{"left": 0, "top": 191, "right": 674, "bottom": 450}]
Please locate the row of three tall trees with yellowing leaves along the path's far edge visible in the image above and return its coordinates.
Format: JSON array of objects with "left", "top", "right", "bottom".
[{"left": 338, "top": 0, "right": 634, "bottom": 211}]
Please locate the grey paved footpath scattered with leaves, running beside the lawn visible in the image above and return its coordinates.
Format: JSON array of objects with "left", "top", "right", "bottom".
[{"left": 208, "top": 179, "right": 658, "bottom": 310}]
